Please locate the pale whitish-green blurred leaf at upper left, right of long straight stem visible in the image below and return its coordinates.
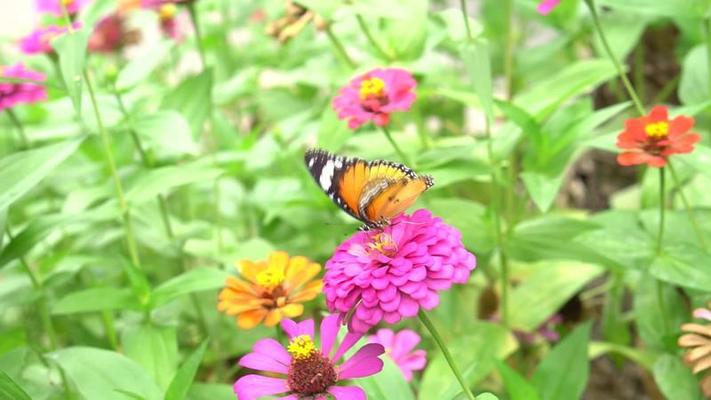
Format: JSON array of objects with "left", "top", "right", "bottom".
[{"left": 133, "top": 111, "right": 200, "bottom": 157}]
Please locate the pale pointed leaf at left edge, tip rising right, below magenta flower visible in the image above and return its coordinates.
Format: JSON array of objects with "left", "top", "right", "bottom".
[{"left": 0, "top": 138, "right": 83, "bottom": 210}]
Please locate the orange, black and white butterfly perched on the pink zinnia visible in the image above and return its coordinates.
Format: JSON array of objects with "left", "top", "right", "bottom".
[{"left": 304, "top": 149, "right": 434, "bottom": 229}]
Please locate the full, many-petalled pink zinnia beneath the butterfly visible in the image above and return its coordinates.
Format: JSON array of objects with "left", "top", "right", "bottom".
[{"left": 323, "top": 209, "right": 476, "bottom": 332}]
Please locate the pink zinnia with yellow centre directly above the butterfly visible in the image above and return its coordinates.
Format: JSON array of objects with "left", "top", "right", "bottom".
[{"left": 333, "top": 68, "right": 417, "bottom": 129}]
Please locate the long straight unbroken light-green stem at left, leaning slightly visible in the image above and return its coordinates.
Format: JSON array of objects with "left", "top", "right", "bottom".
[{"left": 84, "top": 72, "right": 141, "bottom": 269}]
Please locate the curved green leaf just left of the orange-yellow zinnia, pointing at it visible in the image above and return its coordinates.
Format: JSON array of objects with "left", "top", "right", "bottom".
[{"left": 152, "top": 268, "right": 228, "bottom": 307}]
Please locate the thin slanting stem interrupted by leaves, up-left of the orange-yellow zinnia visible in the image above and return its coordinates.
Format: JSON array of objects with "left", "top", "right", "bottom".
[{"left": 114, "top": 89, "right": 208, "bottom": 336}]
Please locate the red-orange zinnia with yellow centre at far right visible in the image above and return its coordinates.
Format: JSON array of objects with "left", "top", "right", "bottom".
[{"left": 617, "top": 106, "right": 701, "bottom": 168}]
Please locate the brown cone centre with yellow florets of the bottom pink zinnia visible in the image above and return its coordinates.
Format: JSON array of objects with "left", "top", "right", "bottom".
[{"left": 287, "top": 335, "right": 338, "bottom": 396}]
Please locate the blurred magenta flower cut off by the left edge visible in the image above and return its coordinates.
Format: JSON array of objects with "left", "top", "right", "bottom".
[{"left": 0, "top": 63, "right": 47, "bottom": 111}]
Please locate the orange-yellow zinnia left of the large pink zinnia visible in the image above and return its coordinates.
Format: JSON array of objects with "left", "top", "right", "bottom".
[{"left": 217, "top": 251, "right": 323, "bottom": 329}]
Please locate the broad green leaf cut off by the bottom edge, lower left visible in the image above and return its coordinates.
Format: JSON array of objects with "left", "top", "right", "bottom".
[{"left": 50, "top": 347, "right": 163, "bottom": 400}]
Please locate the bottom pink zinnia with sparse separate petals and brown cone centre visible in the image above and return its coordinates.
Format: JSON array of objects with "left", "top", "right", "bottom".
[{"left": 234, "top": 315, "right": 385, "bottom": 400}]
